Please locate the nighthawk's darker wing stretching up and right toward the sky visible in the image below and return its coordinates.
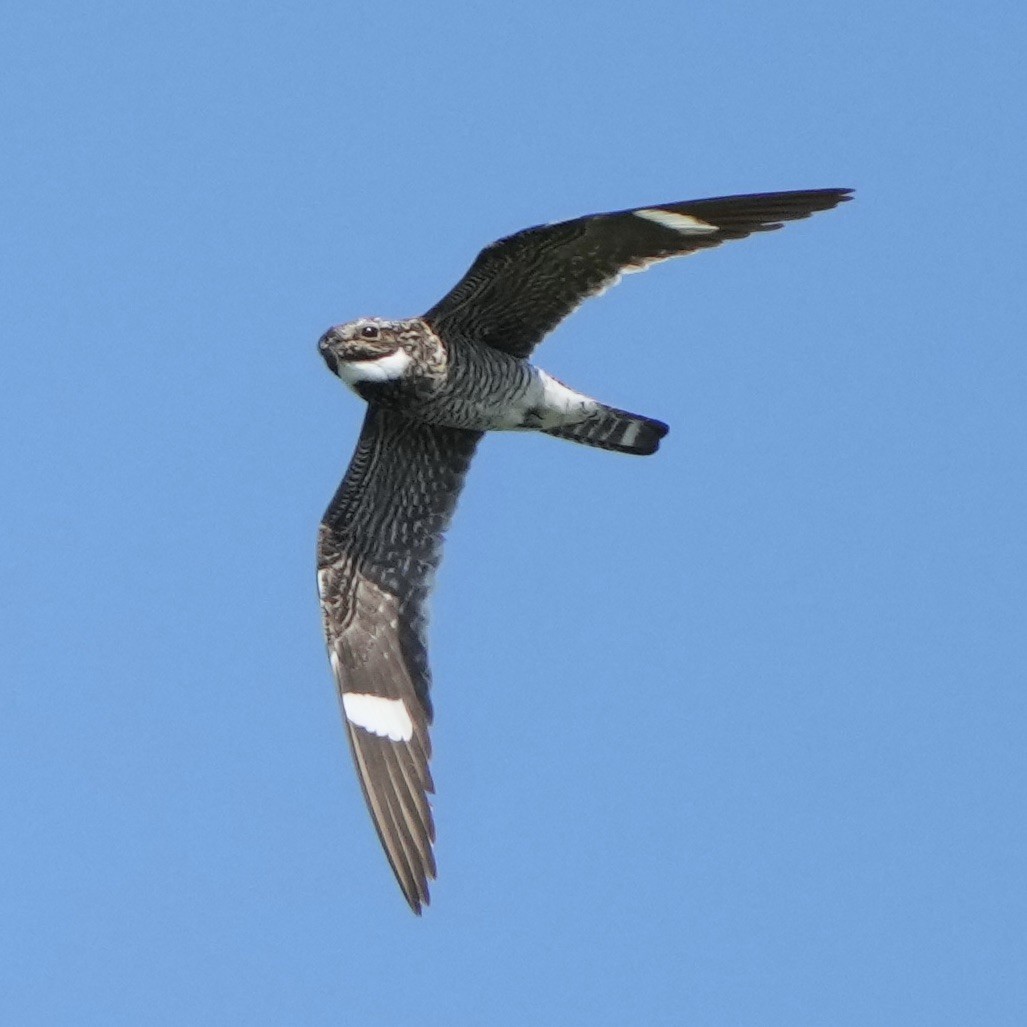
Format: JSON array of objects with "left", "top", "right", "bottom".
[{"left": 424, "top": 189, "right": 851, "bottom": 357}]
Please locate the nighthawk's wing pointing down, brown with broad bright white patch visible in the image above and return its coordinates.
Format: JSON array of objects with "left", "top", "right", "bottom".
[{"left": 317, "top": 405, "right": 481, "bottom": 913}]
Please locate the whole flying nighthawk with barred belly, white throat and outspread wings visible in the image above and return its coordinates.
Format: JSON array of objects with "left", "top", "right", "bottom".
[{"left": 317, "top": 189, "right": 851, "bottom": 913}]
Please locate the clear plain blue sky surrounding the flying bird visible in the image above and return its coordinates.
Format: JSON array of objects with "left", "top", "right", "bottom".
[{"left": 0, "top": 0, "right": 1027, "bottom": 1025}]
